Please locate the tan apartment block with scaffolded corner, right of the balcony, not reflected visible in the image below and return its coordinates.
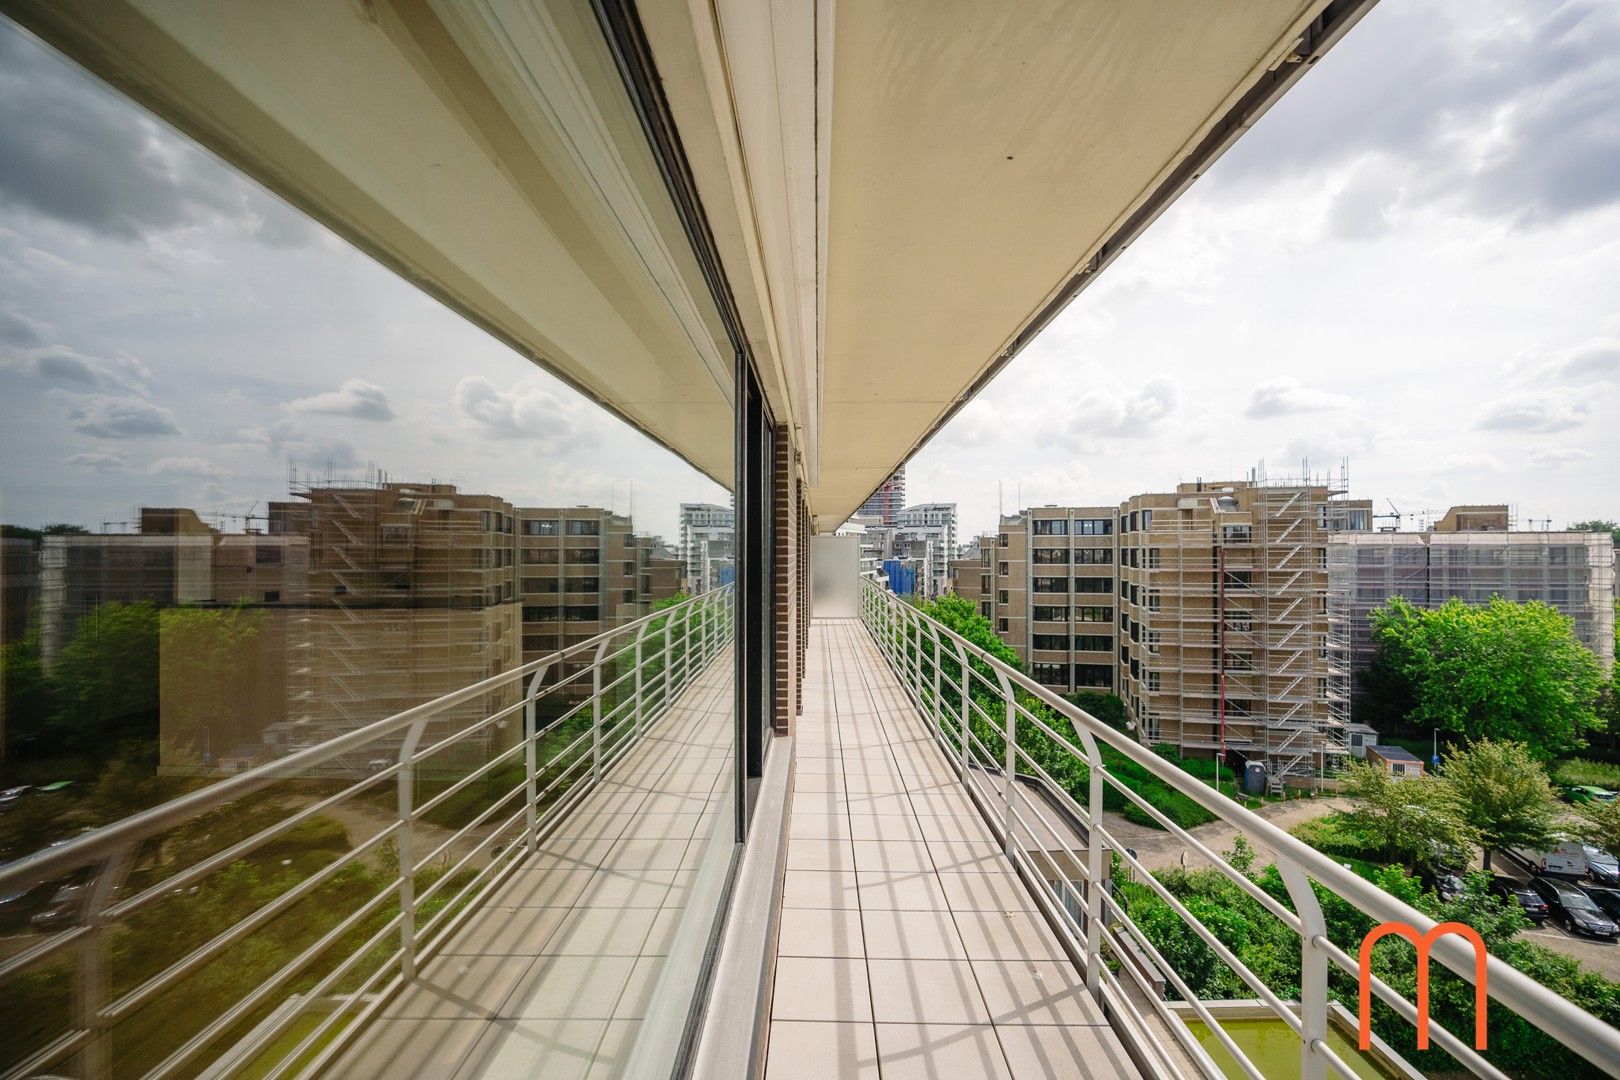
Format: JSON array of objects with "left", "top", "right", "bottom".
[{"left": 951, "top": 478, "right": 1372, "bottom": 772}]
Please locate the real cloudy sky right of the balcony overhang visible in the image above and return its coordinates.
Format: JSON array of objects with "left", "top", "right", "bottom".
[{"left": 907, "top": 0, "right": 1620, "bottom": 536}]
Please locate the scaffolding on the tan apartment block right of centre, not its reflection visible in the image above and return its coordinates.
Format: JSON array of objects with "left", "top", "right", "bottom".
[{"left": 1121, "top": 466, "right": 1371, "bottom": 789}]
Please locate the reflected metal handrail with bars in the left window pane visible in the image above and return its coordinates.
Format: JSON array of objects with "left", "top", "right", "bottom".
[{"left": 0, "top": 585, "right": 734, "bottom": 1077}]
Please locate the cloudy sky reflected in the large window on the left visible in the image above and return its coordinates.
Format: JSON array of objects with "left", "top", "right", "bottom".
[{"left": 0, "top": 19, "right": 727, "bottom": 536}]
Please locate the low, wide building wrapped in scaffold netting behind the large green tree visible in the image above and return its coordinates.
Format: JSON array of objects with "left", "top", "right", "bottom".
[{"left": 1328, "top": 504, "right": 1615, "bottom": 693}]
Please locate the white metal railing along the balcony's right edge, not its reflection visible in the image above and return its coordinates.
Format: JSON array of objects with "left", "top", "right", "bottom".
[{"left": 860, "top": 581, "right": 1620, "bottom": 1080}]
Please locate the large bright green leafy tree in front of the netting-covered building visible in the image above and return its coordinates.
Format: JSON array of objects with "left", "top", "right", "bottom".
[{"left": 1372, "top": 596, "right": 1602, "bottom": 759}]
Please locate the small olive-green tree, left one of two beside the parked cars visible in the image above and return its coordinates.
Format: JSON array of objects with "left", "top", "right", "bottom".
[{"left": 1345, "top": 761, "right": 1479, "bottom": 868}]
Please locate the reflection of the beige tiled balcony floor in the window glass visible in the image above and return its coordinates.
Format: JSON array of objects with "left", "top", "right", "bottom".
[{"left": 329, "top": 653, "right": 734, "bottom": 1080}]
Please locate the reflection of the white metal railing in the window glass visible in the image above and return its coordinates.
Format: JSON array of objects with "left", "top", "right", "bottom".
[{"left": 0, "top": 585, "right": 734, "bottom": 1078}]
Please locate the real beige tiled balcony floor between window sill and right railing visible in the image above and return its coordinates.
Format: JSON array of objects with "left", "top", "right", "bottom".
[{"left": 766, "top": 620, "right": 1137, "bottom": 1080}]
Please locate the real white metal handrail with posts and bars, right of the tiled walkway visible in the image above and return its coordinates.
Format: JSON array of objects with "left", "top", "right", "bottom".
[{"left": 860, "top": 581, "right": 1620, "bottom": 1080}]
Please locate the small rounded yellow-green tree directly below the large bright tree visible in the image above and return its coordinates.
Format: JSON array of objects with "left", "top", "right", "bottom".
[{"left": 1440, "top": 738, "right": 1557, "bottom": 870}]
